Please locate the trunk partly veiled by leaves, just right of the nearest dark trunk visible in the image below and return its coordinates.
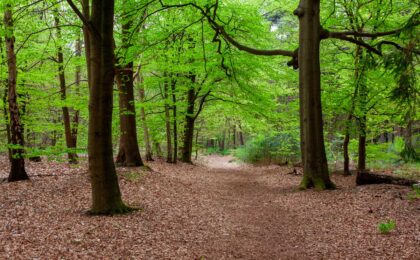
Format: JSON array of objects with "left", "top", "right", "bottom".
[{"left": 117, "top": 1, "right": 143, "bottom": 167}]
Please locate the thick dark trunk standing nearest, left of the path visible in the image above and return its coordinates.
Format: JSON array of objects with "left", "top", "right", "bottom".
[{"left": 81, "top": 0, "right": 130, "bottom": 214}]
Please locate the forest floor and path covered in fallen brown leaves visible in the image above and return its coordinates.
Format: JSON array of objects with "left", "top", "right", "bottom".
[{"left": 0, "top": 156, "right": 420, "bottom": 259}]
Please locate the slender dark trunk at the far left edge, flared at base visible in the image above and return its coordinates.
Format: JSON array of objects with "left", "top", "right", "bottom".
[{"left": 4, "top": 4, "right": 29, "bottom": 182}]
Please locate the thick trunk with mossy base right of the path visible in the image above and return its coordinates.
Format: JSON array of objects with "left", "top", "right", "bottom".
[{"left": 295, "top": 0, "right": 335, "bottom": 190}]
